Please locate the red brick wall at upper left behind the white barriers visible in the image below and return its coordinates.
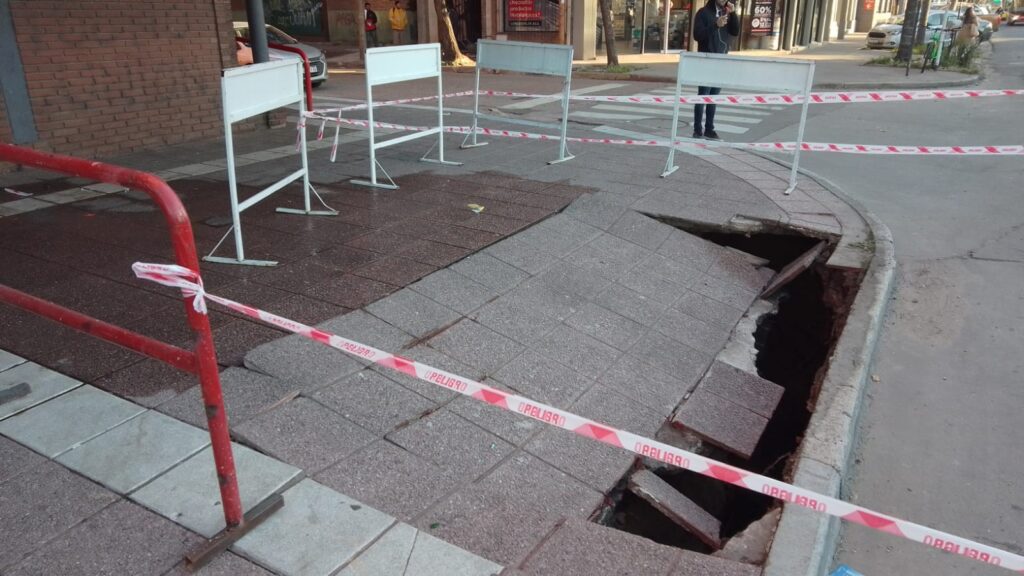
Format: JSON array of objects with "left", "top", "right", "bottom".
[{"left": 7, "top": 0, "right": 236, "bottom": 157}]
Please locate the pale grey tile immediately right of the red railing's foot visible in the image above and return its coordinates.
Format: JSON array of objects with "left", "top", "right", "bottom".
[{"left": 232, "top": 480, "right": 394, "bottom": 576}]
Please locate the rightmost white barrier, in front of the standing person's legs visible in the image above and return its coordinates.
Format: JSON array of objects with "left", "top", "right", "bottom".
[{"left": 662, "top": 52, "right": 814, "bottom": 194}]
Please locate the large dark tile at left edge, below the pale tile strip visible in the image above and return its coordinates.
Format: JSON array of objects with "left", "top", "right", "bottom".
[{"left": 0, "top": 459, "right": 118, "bottom": 574}]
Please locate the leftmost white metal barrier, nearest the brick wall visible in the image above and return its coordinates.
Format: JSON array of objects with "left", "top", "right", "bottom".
[{"left": 203, "top": 58, "right": 338, "bottom": 266}]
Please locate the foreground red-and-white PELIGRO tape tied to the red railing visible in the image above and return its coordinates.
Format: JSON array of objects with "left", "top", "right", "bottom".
[{"left": 132, "top": 262, "right": 1024, "bottom": 574}]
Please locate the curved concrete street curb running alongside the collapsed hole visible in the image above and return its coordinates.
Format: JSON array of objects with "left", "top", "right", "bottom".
[{"left": 759, "top": 155, "right": 896, "bottom": 576}]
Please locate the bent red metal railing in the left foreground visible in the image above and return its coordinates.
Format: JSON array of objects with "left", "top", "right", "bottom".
[{"left": 0, "top": 143, "right": 245, "bottom": 531}]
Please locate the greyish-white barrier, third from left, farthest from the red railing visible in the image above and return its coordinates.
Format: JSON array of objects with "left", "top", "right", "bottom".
[{"left": 462, "top": 40, "right": 573, "bottom": 164}]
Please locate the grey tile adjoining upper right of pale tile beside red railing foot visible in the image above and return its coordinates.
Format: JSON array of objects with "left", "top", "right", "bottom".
[{"left": 315, "top": 440, "right": 456, "bottom": 522}]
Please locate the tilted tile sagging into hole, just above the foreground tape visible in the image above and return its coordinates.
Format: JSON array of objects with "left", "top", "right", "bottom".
[{"left": 672, "top": 387, "right": 768, "bottom": 458}]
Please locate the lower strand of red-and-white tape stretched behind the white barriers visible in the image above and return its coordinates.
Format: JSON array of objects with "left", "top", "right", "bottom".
[{"left": 296, "top": 113, "right": 1024, "bottom": 156}]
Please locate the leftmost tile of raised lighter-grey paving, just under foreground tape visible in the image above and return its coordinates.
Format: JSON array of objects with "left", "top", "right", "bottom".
[{"left": 245, "top": 334, "right": 366, "bottom": 389}]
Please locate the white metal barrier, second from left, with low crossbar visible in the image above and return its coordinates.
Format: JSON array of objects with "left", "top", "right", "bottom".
[{"left": 351, "top": 43, "right": 462, "bottom": 190}]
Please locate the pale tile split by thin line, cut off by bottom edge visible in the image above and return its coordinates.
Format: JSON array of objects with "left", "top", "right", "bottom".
[{"left": 339, "top": 524, "right": 502, "bottom": 576}]
